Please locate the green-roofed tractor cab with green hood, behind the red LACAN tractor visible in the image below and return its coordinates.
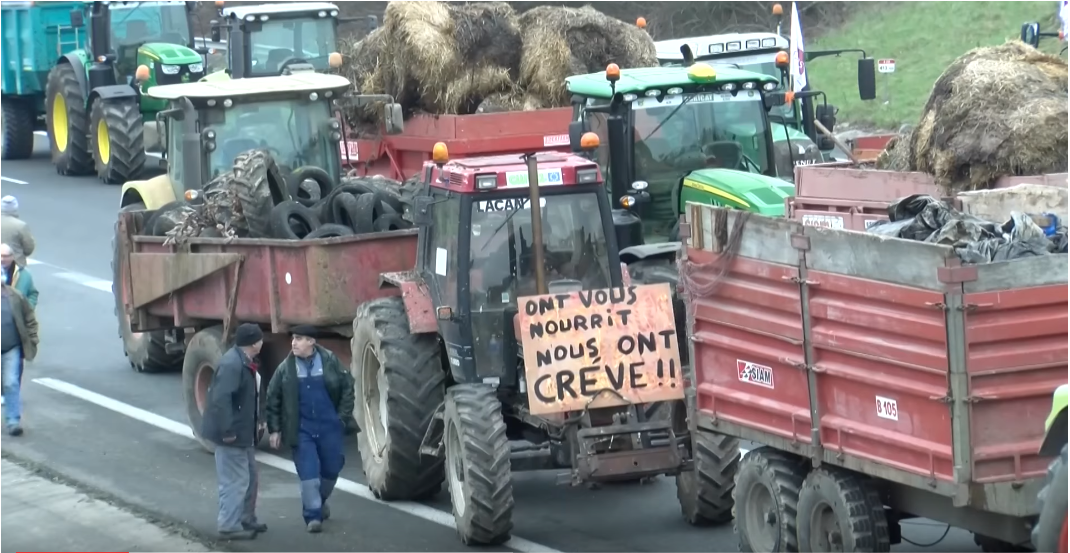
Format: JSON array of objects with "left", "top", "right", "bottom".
[{"left": 566, "top": 63, "right": 794, "bottom": 244}]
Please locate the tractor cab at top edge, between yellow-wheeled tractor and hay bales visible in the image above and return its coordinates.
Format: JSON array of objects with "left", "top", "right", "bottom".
[{"left": 209, "top": 2, "right": 338, "bottom": 79}]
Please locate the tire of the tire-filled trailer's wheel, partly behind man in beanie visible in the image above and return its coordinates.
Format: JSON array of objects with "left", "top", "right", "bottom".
[{"left": 182, "top": 326, "right": 227, "bottom": 452}]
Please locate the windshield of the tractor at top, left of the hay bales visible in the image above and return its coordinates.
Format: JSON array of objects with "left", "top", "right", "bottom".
[{"left": 249, "top": 17, "right": 338, "bottom": 75}]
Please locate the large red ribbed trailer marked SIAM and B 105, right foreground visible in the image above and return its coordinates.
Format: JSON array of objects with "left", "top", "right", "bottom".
[{"left": 681, "top": 204, "right": 1068, "bottom": 551}]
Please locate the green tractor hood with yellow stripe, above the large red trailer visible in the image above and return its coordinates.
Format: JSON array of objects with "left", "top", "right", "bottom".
[{"left": 681, "top": 169, "right": 795, "bottom": 217}]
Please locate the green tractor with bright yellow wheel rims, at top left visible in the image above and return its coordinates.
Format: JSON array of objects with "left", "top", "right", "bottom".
[{"left": 45, "top": 1, "right": 204, "bottom": 184}]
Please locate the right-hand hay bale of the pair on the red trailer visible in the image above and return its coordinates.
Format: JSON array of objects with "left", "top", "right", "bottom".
[{"left": 519, "top": 5, "right": 658, "bottom": 107}]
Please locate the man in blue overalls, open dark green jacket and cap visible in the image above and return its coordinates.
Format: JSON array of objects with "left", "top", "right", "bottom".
[{"left": 266, "top": 325, "right": 355, "bottom": 533}]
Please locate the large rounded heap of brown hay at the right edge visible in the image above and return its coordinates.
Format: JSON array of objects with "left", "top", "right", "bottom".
[{"left": 878, "top": 41, "right": 1068, "bottom": 196}]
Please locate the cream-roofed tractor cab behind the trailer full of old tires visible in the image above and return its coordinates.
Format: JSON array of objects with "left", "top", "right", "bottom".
[{"left": 123, "top": 72, "right": 401, "bottom": 209}]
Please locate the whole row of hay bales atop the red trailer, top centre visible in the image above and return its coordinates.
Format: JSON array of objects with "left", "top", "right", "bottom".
[{"left": 341, "top": 1, "right": 657, "bottom": 124}]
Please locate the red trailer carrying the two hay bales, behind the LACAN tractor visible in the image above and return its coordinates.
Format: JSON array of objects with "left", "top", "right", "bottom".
[{"left": 340, "top": 108, "right": 572, "bottom": 181}]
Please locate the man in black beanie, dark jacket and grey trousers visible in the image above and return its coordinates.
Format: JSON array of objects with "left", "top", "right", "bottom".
[{"left": 201, "top": 323, "right": 268, "bottom": 539}]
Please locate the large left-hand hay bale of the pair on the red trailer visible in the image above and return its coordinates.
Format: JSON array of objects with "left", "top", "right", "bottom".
[{"left": 362, "top": 1, "right": 520, "bottom": 114}]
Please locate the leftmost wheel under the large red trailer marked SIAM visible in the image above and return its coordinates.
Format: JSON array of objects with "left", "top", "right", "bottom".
[{"left": 732, "top": 447, "right": 807, "bottom": 552}]
